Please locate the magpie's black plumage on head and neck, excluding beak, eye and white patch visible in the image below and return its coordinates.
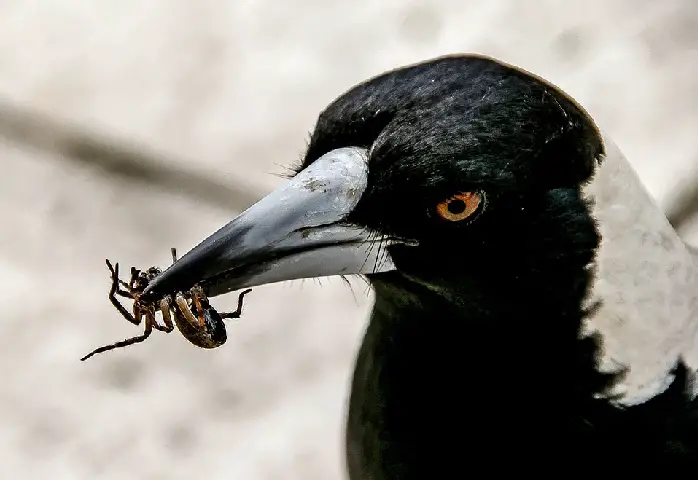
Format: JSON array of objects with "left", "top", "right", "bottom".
[{"left": 300, "top": 56, "right": 698, "bottom": 480}]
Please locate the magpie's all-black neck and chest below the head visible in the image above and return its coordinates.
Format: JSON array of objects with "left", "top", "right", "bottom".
[{"left": 348, "top": 270, "right": 698, "bottom": 472}]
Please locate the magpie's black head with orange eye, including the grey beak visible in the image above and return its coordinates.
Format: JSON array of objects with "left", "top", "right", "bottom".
[{"left": 146, "top": 55, "right": 604, "bottom": 308}]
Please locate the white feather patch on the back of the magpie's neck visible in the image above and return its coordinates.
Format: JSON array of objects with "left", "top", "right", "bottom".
[{"left": 584, "top": 136, "right": 698, "bottom": 405}]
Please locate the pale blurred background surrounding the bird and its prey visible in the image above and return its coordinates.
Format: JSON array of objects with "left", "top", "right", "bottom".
[{"left": 0, "top": 0, "right": 698, "bottom": 480}]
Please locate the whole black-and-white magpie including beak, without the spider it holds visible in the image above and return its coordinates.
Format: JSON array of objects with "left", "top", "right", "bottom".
[{"left": 140, "top": 55, "right": 698, "bottom": 480}]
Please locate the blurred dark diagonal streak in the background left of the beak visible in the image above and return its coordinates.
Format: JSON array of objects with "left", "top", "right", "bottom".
[{"left": 0, "top": 100, "right": 262, "bottom": 211}]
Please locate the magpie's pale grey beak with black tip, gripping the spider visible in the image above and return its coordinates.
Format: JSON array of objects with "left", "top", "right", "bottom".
[{"left": 144, "top": 147, "right": 398, "bottom": 298}]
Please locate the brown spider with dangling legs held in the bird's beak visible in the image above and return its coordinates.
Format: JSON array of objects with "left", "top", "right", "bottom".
[{"left": 80, "top": 248, "right": 252, "bottom": 361}]
